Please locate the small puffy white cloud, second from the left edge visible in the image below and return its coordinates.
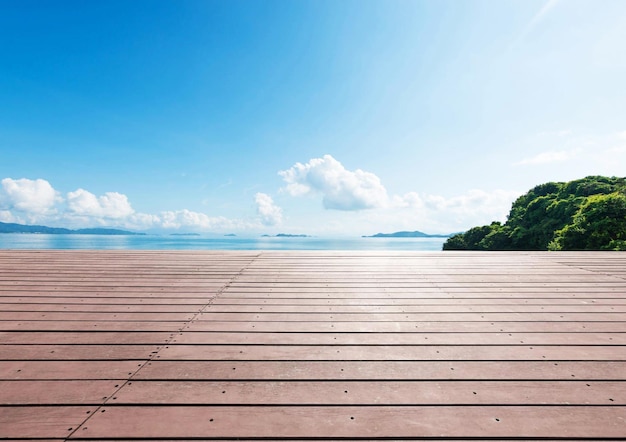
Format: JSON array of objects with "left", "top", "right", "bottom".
[{"left": 67, "top": 189, "right": 134, "bottom": 220}]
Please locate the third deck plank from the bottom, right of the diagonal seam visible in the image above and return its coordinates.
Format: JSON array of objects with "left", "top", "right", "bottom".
[{"left": 134, "top": 360, "right": 626, "bottom": 381}]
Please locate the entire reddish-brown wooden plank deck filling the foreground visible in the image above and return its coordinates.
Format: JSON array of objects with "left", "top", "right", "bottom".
[{"left": 0, "top": 250, "right": 626, "bottom": 440}]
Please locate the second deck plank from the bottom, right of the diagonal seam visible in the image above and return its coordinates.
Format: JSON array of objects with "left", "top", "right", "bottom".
[{"left": 112, "top": 380, "right": 626, "bottom": 405}]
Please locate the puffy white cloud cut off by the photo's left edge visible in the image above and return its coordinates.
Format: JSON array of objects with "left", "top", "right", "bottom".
[{"left": 0, "top": 178, "right": 62, "bottom": 216}]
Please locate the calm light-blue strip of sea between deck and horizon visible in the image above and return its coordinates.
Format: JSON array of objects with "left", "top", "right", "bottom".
[{"left": 0, "top": 233, "right": 445, "bottom": 251}]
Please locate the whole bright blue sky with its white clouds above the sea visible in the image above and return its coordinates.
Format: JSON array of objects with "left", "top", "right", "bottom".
[{"left": 0, "top": 0, "right": 626, "bottom": 236}]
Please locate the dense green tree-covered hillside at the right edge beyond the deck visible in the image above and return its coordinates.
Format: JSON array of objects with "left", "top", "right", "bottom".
[{"left": 443, "top": 176, "right": 626, "bottom": 250}]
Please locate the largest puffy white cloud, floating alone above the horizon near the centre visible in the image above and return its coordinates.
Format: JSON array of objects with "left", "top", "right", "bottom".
[{"left": 279, "top": 155, "right": 388, "bottom": 210}]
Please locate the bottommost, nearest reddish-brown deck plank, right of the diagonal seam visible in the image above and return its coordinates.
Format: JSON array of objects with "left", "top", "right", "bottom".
[{"left": 75, "top": 406, "right": 626, "bottom": 438}]
